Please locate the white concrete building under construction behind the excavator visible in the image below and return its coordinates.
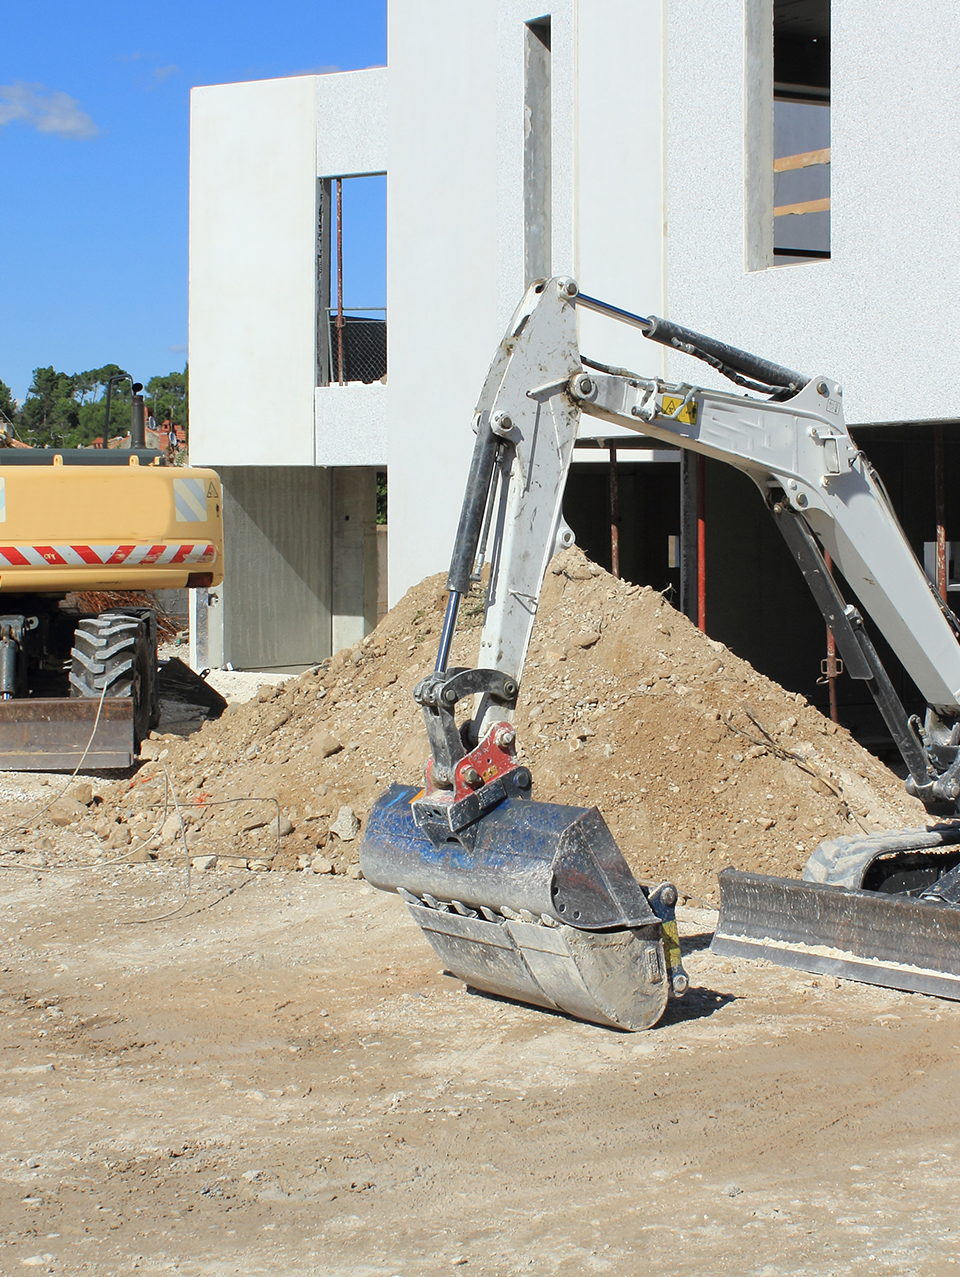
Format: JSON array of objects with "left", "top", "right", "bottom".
[{"left": 190, "top": 0, "right": 960, "bottom": 720}]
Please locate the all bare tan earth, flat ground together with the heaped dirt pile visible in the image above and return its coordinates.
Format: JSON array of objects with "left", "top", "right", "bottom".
[{"left": 0, "top": 552, "right": 960, "bottom": 1277}]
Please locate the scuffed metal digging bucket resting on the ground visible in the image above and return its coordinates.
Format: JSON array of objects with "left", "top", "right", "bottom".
[{"left": 360, "top": 785, "right": 686, "bottom": 1029}]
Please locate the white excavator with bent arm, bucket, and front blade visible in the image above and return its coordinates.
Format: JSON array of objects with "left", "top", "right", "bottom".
[{"left": 361, "top": 277, "right": 960, "bottom": 1029}]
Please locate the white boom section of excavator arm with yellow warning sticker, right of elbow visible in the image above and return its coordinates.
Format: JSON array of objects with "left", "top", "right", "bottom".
[{"left": 571, "top": 303, "right": 960, "bottom": 815}]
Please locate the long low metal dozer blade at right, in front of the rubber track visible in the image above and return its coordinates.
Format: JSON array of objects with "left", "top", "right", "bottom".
[{"left": 710, "top": 870, "right": 960, "bottom": 1000}]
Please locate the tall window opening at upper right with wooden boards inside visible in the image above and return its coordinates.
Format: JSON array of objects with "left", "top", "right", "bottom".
[{"left": 774, "top": 0, "right": 830, "bottom": 266}]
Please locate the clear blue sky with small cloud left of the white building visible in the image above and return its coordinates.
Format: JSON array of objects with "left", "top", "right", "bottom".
[{"left": 0, "top": 0, "right": 387, "bottom": 400}]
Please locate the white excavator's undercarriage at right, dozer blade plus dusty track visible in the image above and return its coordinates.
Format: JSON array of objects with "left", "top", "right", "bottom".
[{"left": 710, "top": 825, "right": 960, "bottom": 1000}]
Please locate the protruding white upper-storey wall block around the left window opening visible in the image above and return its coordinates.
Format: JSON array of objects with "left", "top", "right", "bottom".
[{"left": 190, "top": 68, "right": 387, "bottom": 466}]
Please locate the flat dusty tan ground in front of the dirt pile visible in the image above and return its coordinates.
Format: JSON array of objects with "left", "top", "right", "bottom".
[{"left": 0, "top": 847, "right": 960, "bottom": 1277}]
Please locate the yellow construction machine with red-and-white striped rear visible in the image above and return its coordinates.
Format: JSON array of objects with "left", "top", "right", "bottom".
[{"left": 0, "top": 408, "right": 223, "bottom": 770}]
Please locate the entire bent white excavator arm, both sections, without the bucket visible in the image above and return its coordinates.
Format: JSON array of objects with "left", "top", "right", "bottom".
[{"left": 426, "top": 280, "right": 960, "bottom": 815}]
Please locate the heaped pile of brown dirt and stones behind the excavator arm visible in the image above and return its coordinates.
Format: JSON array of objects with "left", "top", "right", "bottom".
[{"left": 50, "top": 549, "right": 924, "bottom": 902}]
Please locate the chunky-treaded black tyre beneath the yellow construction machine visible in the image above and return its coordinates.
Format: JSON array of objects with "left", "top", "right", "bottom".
[{"left": 70, "top": 608, "right": 160, "bottom": 747}]
